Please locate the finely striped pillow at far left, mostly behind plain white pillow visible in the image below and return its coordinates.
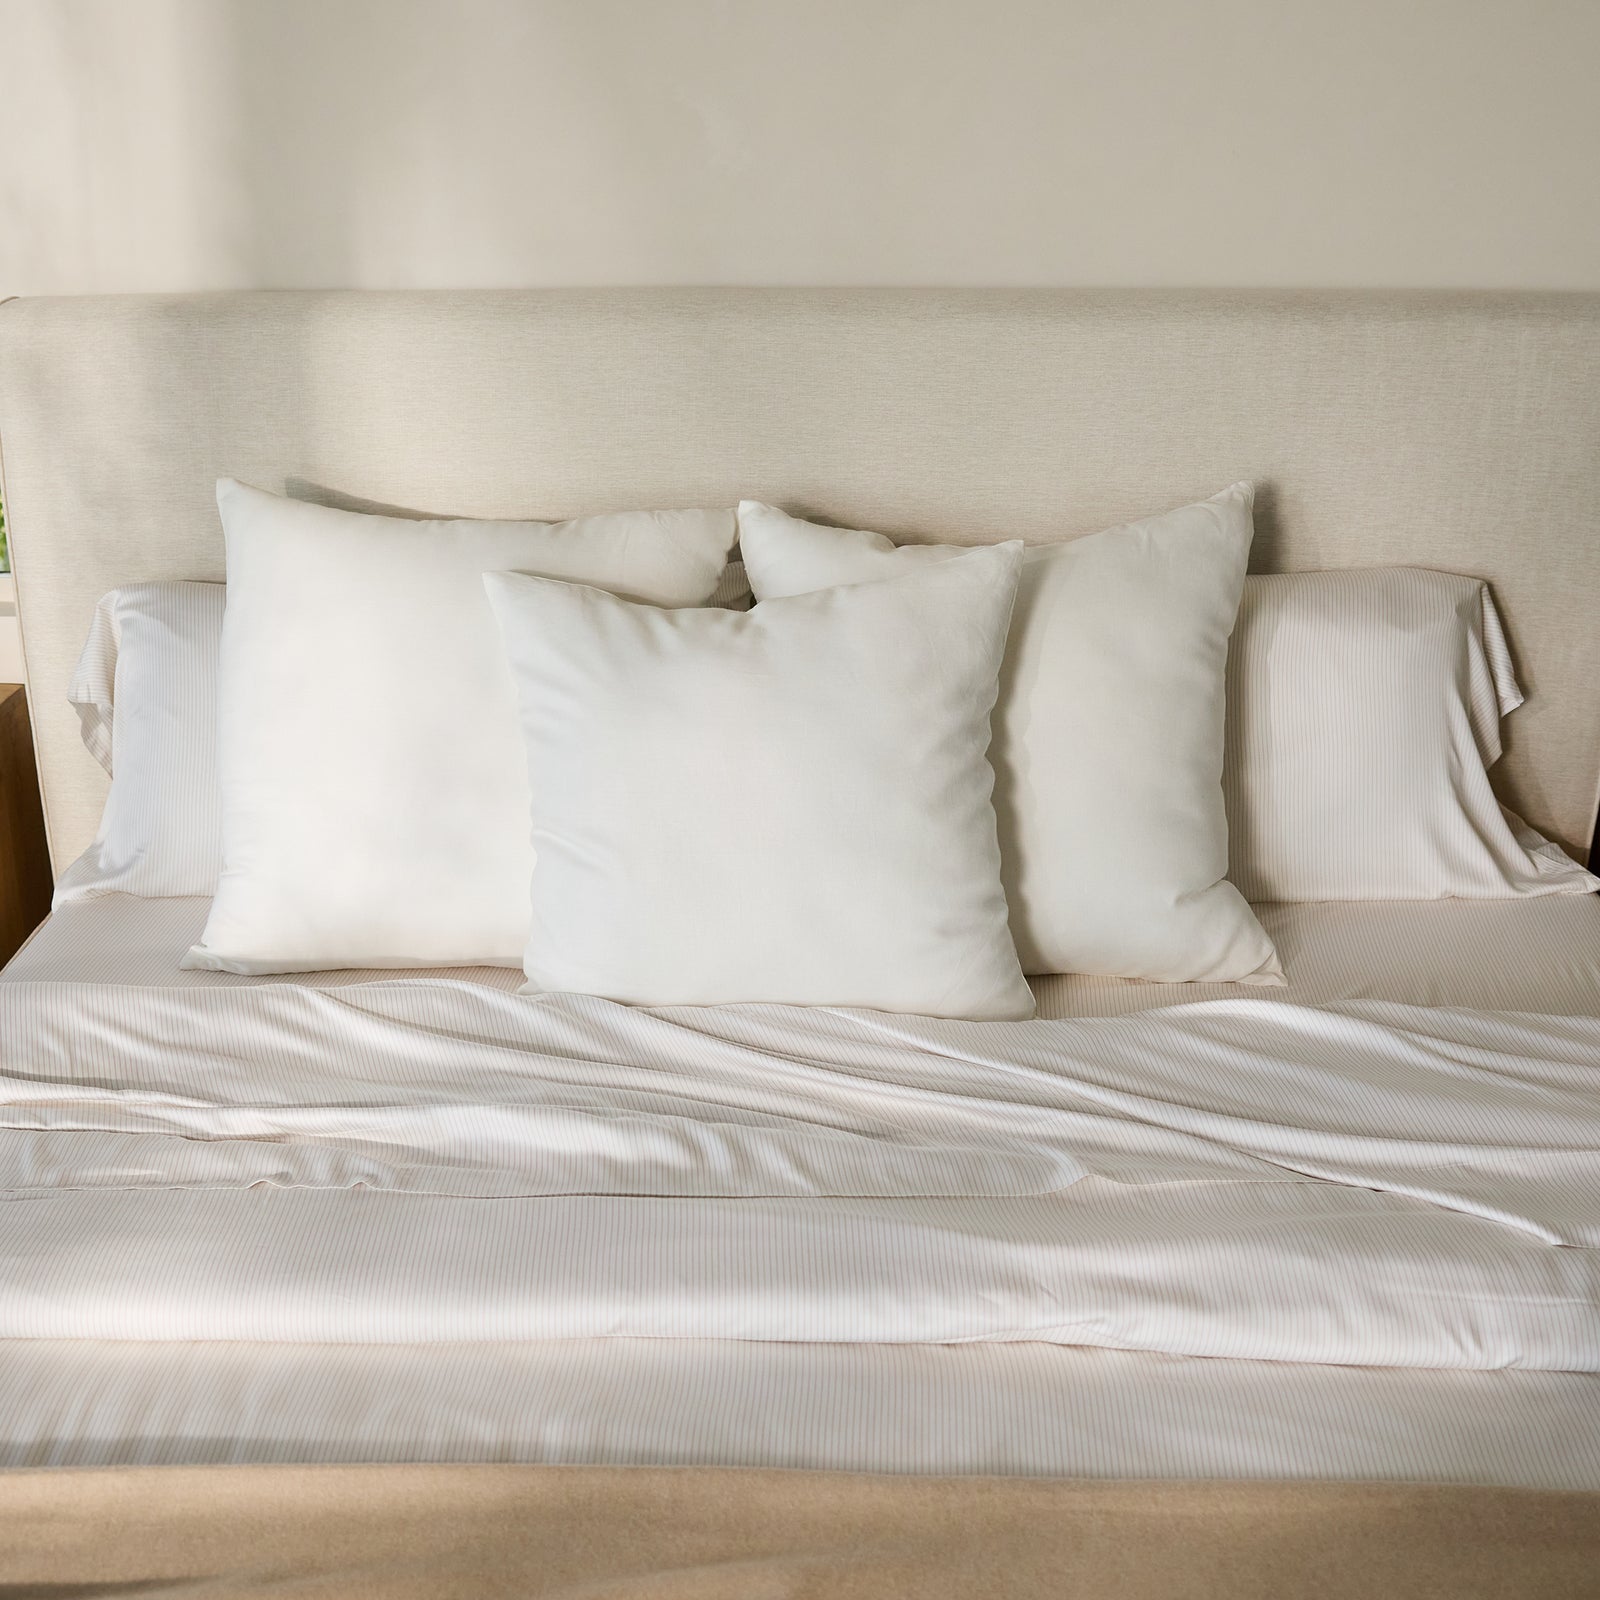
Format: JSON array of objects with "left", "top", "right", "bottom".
[{"left": 54, "top": 582, "right": 226, "bottom": 906}]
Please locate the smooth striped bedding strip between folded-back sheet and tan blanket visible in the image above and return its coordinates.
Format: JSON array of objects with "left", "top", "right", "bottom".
[{"left": 0, "top": 1339, "right": 1600, "bottom": 1490}]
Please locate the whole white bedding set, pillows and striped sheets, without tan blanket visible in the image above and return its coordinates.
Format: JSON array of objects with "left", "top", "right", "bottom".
[{"left": 0, "top": 480, "right": 1600, "bottom": 1592}]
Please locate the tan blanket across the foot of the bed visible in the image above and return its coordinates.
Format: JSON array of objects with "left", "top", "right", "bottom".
[{"left": 0, "top": 1466, "right": 1600, "bottom": 1600}]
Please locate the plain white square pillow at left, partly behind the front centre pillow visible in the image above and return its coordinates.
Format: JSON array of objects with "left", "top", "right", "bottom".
[{"left": 186, "top": 478, "right": 734, "bottom": 973}]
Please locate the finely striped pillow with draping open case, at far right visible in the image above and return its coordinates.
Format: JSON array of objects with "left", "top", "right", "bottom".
[{"left": 1224, "top": 566, "right": 1600, "bottom": 901}]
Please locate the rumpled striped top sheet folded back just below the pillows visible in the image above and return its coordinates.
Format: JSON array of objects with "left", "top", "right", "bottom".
[{"left": 0, "top": 978, "right": 1600, "bottom": 1373}]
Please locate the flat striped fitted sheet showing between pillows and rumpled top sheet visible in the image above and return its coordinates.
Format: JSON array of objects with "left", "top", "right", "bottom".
[{"left": 9, "top": 894, "right": 1600, "bottom": 1018}]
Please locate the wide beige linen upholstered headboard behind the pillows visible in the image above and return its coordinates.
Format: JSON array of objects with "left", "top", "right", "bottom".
[{"left": 0, "top": 290, "right": 1600, "bottom": 869}]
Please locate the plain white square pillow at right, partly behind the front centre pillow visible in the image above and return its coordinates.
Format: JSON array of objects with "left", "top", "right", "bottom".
[{"left": 739, "top": 483, "right": 1282, "bottom": 982}]
